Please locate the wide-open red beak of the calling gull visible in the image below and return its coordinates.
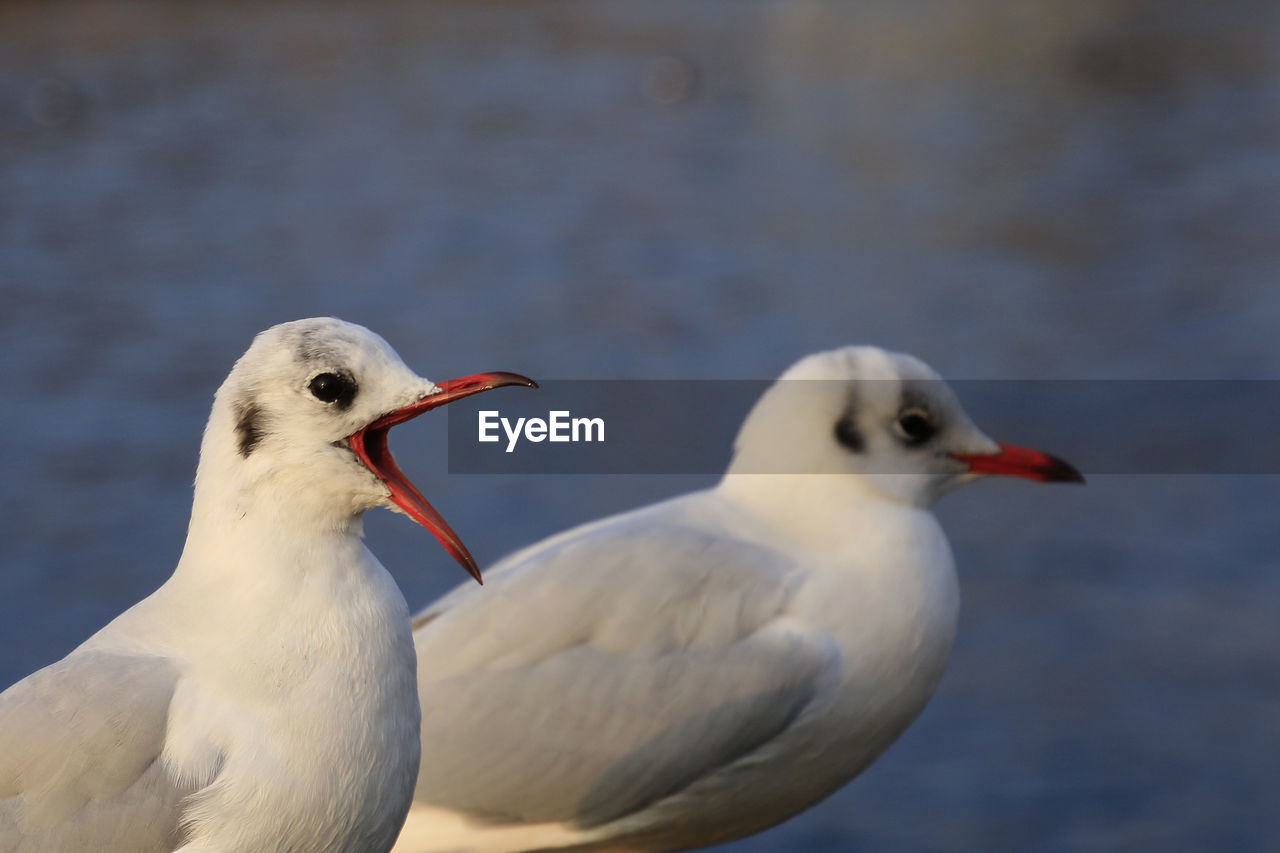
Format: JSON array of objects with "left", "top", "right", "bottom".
[{"left": 347, "top": 373, "right": 538, "bottom": 583}]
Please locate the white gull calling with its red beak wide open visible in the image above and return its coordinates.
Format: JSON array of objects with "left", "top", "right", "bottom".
[{"left": 0, "top": 319, "right": 532, "bottom": 853}]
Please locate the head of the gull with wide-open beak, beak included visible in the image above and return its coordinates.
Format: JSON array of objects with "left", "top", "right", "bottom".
[{"left": 193, "top": 318, "right": 536, "bottom": 580}]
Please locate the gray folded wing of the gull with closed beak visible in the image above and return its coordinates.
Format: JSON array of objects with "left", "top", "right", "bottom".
[{"left": 415, "top": 507, "right": 836, "bottom": 826}]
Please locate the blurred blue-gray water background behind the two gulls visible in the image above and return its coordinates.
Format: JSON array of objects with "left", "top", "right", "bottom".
[{"left": 0, "top": 0, "right": 1280, "bottom": 853}]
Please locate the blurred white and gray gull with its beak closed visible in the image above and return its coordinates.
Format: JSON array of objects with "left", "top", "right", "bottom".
[{"left": 394, "top": 347, "right": 1083, "bottom": 853}]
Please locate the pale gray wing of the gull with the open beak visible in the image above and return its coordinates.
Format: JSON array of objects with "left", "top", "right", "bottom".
[{"left": 0, "top": 651, "right": 191, "bottom": 853}]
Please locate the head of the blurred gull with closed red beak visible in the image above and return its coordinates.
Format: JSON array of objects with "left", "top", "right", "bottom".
[{"left": 730, "top": 347, "right": 1084, "bottom": 507}]
